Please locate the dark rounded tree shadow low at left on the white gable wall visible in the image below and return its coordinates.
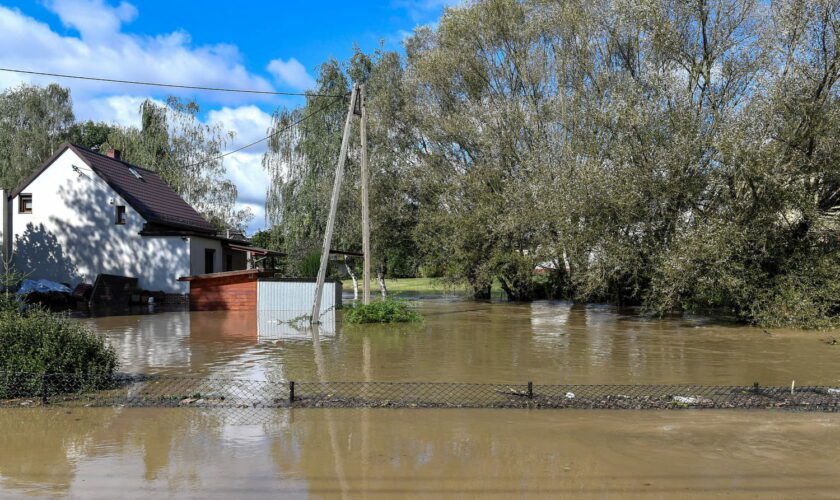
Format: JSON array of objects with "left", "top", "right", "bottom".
[{"left": 14, "top": 223, "right": 81, "bottom": 284}]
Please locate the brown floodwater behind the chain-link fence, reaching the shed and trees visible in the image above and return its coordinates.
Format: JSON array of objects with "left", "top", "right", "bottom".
[{"left": 88, "top": 299, "right": 840, "bottom": 385}]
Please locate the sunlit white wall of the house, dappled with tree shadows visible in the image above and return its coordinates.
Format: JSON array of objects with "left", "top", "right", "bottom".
[{"left": 11, "top": 149, "right": 192, "bottom": 293}]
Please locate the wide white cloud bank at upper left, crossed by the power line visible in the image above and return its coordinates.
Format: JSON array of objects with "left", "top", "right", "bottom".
[{"left": 0, "top": 0, "right": 273, "bottom": 102}]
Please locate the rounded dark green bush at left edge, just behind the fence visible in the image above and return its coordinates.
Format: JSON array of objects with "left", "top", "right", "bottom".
[{"left": 0, "top": 302, "right": 117, "bottom": 397}]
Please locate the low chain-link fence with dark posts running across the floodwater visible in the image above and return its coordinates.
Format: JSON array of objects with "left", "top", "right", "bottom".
[{"left": 0, "top": 373, "right": 840, "bottom": 411}]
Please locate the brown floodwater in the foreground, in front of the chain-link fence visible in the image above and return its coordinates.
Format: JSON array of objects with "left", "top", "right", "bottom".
[{"left": 0, "top": 408, "right": 840, "bottom": 499}]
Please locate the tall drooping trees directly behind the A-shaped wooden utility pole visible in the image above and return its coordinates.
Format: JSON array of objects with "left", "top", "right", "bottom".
[{"left": 263, "top": 51, "right": 417, "bottom": 288}]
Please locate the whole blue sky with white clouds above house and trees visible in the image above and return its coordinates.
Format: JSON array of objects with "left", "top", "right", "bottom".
[{"left": 0, "top": 0, "right": 458, "bottom": 231}]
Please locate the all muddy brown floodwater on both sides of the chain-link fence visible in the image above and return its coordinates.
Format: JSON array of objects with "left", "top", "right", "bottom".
[{"left": 0, "top": 299, "right": 840, "bottom": 499}]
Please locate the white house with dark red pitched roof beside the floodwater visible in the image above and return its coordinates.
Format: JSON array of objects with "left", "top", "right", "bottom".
[{"left": 0, "top": 144, "right": 276, "bottom": 293}]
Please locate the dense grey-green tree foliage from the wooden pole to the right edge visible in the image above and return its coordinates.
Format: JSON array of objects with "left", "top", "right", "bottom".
[{"left": 266, "top": 0, "right": 840, "bottom": 326}]
